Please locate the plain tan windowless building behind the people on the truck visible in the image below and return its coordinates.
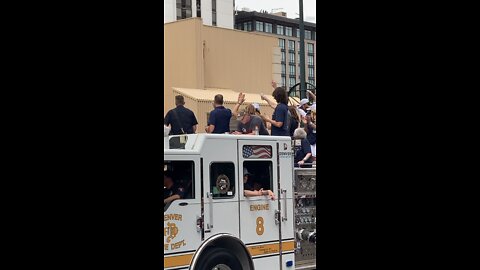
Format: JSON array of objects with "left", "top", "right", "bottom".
[{"left": 164, "top": 18, "right": 288, "bottom": 131}]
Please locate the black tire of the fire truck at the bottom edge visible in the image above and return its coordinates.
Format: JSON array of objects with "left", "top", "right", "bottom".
[{"left": 195, "top": 247, "right": 242, "bottom": 270}]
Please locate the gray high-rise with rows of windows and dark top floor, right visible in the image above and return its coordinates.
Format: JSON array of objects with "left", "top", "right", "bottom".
[{"left": 235, "top": 11, "right": 317, "bottom": 89}]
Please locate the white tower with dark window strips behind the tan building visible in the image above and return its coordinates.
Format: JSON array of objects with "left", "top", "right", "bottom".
[{"left": 163, "top": 0, "right": 235, "bottom": 29}]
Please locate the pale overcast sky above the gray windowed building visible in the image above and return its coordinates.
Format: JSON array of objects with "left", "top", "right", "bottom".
[{"left": 235, "top": 0, "right": 317, "bottom": 23}]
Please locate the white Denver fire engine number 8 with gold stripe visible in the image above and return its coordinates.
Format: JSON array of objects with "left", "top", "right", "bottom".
[{"left": 163, "top": 127, "right": 316, "bottom": 270}]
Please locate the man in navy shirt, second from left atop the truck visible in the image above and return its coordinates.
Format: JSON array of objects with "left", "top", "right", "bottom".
[{"left": 207, "top": 94, "right": 232, "bottom": 134}]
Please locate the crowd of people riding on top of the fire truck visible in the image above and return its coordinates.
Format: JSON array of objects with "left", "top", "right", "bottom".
[{"left": 164, "top": 82, "right": 317, "bottom": 167}]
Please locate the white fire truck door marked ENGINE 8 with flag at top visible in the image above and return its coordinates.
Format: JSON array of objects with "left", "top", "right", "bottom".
[{"left": 238, "top": 140, "right": 280, "bottom": 255}]
